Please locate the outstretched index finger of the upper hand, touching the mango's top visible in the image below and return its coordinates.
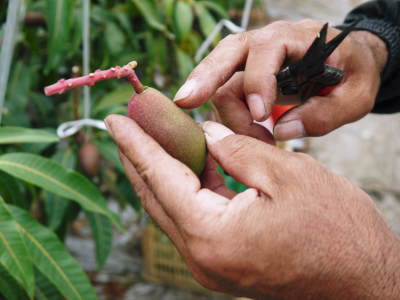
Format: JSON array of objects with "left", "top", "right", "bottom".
[{"left": 174, "top": 33, "right": 248, "bottom": 108}]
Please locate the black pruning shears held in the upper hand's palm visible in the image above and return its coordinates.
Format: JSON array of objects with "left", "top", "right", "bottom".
[{"left": 276, "top": 20, "right": 358, "bottom": 101}]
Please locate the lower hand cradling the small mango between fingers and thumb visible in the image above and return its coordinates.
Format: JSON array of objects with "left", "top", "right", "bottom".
[{"left": 106, "top": 115, "right": 400, "bottom": 299}]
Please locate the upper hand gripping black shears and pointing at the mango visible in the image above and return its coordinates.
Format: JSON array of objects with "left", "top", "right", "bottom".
[{"left": 175, "top": 20, "right": 387, "bottom": 140}]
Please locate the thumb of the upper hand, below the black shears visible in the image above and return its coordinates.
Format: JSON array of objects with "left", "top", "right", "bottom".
[{"left": 274, "top": 75, "right": 379, "bottom": 141}]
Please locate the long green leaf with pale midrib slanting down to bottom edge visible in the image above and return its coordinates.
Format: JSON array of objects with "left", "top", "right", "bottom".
[{"left": 9, "top": 205, "right": 96, "bottom": 300}]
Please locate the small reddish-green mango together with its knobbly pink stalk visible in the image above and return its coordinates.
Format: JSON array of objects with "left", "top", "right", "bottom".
[{"left": 45, "top": 62, "right": 207, "bottom": 175}]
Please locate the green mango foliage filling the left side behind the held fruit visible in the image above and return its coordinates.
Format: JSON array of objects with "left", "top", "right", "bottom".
[{"left": 0, "top": 0, "right": 256, "bottom": 299}]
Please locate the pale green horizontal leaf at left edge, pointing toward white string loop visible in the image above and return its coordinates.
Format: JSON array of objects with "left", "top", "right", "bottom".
[{"left": 0, "top": 126, "right": 59, "bottom": 144}]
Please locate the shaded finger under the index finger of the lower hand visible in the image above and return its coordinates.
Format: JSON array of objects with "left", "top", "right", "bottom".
[{"left": 120, "top": 152, "right": 184, "bottom": 248}]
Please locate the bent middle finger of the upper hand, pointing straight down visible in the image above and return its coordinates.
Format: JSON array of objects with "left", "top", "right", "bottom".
[{"left": 244, "top": 41, "right": 286, "bottom": 121}]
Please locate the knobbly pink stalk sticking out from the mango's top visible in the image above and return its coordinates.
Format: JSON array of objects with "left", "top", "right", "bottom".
[{"left": 44, "top": 61, "right": 144, "bottom": 96}]
